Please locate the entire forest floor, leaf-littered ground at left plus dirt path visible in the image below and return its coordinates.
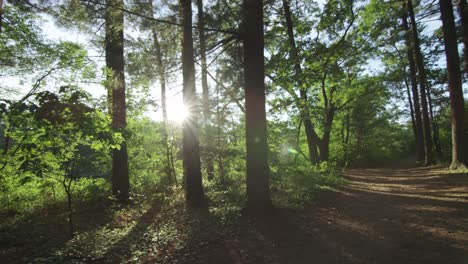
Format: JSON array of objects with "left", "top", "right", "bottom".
[{"left": 0, "top": 167, "right": 468, "bottom": 264}]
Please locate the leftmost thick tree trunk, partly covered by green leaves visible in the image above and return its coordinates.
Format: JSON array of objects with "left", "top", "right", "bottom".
[{"left": 105, "top": 0, "right": 130, "bottom": 202}]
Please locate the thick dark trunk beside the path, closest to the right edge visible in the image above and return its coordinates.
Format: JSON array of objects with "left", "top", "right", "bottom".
[{"left": 439, "top": 0, "right": 468, "bottom": 169}]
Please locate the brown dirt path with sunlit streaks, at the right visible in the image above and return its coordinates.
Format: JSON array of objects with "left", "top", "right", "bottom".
[{"left": 185, "top": 168, "right": 468, "bottom": 264}]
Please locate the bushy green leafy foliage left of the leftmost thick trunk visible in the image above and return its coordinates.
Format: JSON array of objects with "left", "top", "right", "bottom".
[{"left": 0, "top": 86, "right": 122, "bottom": 211}]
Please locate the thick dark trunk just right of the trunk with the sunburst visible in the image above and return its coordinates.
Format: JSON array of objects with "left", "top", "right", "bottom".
[{"left": 243, "top": 0, "right": 272, "bottom": 212}]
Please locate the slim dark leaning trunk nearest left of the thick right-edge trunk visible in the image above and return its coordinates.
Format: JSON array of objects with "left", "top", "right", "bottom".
[{"left": 407, "top": 0, "right": 434, "bottom": 166}]
